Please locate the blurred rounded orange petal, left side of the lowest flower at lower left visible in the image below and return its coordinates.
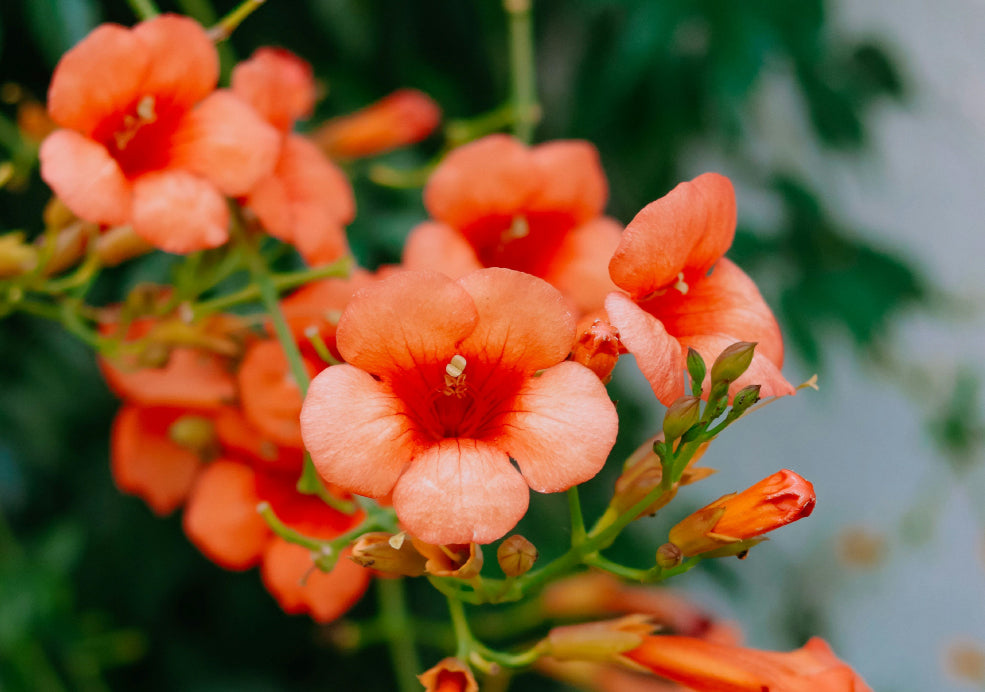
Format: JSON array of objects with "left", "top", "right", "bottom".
[{"left": 183, "top": 459, "right": 273, "bottom": 570}]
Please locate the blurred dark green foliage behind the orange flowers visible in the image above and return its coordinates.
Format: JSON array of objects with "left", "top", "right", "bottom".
[{"left": 0, "top": 0, "right": 936, "bottom": 692}]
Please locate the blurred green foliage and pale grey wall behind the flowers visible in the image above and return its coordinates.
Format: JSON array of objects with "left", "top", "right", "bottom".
[{"left": 0, "top": 0, "right": 985, "bottom": 692}]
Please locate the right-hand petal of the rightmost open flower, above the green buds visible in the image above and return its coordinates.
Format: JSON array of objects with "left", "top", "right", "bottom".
[{"left": 643, "top": 258, "right": 783, "bottom": 368}]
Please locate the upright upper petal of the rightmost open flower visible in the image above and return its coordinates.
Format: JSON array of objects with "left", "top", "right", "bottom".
[{"left": 609, "top": 173, "right": 736, "bottom": 298}]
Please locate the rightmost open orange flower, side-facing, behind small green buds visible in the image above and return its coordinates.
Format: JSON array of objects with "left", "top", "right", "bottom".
[{"left": 605, "top": 173, "right": 794, "bottom": 405}]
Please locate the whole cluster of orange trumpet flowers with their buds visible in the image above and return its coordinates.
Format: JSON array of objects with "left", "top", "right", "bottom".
[{"left": 32, "top": 16, "right": 868, "bottom": 692}]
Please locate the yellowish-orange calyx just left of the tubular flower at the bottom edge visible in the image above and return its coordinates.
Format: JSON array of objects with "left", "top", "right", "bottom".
[{"left": 545, "top": 613, "right": 656, "bottom": 662}]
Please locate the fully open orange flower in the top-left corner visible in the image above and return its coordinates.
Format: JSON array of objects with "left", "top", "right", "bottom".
[{"left": 40, "top": 15, "right": 279, "bottom": 253}]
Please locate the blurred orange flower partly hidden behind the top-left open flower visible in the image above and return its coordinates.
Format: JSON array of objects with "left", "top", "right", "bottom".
[{"left": 232, "top": 48, "right": 356, "bottom": 265}]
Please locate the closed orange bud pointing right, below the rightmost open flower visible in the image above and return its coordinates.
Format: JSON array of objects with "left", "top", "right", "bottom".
[{"left": 669, "top": 469, "right": 815, "bottom": 557}]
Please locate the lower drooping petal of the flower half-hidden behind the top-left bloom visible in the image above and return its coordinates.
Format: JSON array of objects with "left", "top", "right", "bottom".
[{"left": 246, "top": 136, "right": 356, "bottom": 265}]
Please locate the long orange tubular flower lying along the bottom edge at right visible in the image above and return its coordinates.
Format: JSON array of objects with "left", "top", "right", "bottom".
[{"left": 624, "top": 636, "right": 872, "bottom": 692}]
